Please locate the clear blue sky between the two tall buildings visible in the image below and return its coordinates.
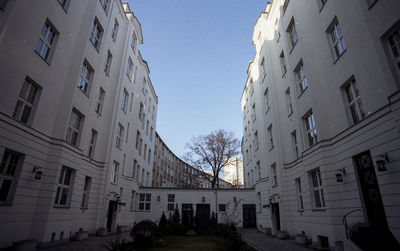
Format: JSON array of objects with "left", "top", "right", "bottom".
[{"left": 129, "top": 0, "right": 266, "bottom": 157}]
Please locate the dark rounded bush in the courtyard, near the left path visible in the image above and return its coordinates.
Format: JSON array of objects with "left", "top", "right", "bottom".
[{"left": 131, "top": 220, "right": 160, "bottom": 248}]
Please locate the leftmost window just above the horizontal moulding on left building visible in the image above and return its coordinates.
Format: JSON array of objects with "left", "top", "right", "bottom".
[{"left": 13, "top": 77, "right": 40, "bottom": 124}]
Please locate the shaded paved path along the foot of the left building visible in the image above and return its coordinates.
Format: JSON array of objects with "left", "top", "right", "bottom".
[{"left": 38, "top": 232, "right": 132, "bottom": 251}]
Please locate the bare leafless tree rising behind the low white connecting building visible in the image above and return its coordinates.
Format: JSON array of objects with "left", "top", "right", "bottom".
[{"left": 185, "top": 129, "right": 240, "bottom": 188}]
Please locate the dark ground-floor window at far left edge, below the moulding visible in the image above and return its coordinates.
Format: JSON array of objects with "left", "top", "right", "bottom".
[{"left": 0, "top": 149, "right": 24, "bottom": 205}]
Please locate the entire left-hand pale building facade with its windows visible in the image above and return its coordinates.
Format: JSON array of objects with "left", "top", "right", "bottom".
[{"left": 0, "top": 0, "right": 158, "bottom": 246}]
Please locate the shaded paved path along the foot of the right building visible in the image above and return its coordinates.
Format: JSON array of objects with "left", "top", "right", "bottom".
[{"left": 240, "top": 229, "right": 315, "bottom": 251}]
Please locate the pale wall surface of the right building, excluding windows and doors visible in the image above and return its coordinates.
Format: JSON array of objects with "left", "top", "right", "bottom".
[{"left": 241, "top": 0, "right": 400, "bottom": 248}]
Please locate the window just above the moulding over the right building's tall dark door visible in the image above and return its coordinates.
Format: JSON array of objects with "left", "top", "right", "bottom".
[{"left": 342, "top": 78, "right": 365, "bottom": 123}]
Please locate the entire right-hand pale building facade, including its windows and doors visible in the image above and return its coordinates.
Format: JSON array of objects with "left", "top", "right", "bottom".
[{"left": 241, "top": 0, "right": 400, "bottom": 250}]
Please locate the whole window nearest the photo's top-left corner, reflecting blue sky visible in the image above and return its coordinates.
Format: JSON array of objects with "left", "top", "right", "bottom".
[{"left": 35, "top": 19, "right": 58, "bottom": 63}]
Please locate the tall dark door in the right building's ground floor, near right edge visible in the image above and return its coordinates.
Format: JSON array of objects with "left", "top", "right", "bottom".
[{"left": 353, "top": 151, "right": 388, "bottom": 229}]
